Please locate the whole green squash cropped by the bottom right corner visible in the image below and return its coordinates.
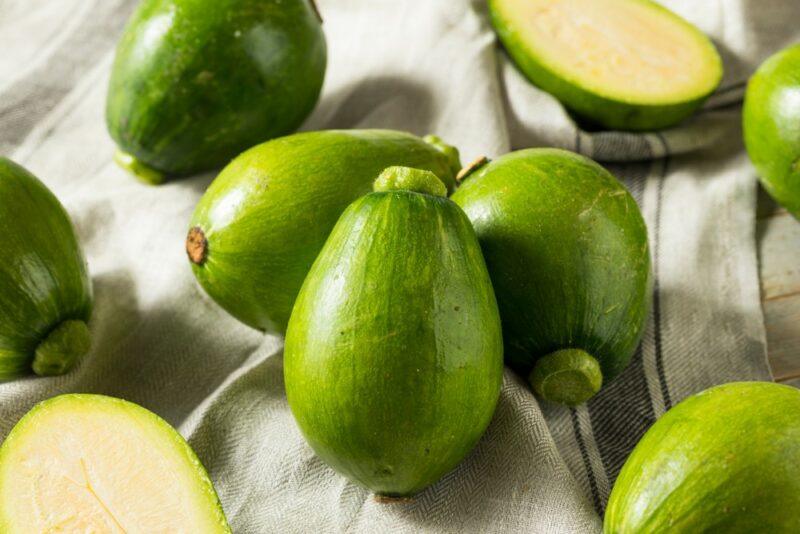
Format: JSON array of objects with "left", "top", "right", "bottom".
[{"left": 605, "top": 382, "right": 800, "bottom": 534}]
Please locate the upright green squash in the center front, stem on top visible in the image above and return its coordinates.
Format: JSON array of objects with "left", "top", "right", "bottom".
[{"left": 284, "top": 167, "right": 503, "bottom": 498}]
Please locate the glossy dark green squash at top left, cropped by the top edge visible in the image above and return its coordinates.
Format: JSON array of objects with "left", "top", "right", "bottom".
[{"left": 106, "top": 0, "right": 327, "bottom": 183}]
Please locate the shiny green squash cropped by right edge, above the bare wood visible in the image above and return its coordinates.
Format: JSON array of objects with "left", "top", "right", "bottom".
[{"left": 743, "top": 45, "right": 800, "bottom": 219}]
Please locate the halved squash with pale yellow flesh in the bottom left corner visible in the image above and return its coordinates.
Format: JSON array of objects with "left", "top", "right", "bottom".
[{"left": 0, "top": 394, "right": 231, "bottom": 534}]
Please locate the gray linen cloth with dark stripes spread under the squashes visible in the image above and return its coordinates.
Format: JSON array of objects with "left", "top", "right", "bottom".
[{"left": 0, "top": 0, "right": 800, "bottom": 533}]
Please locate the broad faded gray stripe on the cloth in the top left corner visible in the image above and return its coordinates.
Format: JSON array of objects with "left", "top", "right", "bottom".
[{"left": 0, "top": 0, "right": 135, "bottom": 153}]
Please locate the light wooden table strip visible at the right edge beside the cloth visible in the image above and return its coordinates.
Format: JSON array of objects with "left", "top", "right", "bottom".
[{"left": 756, "top": 189, "right": 800, "bottom": 387}]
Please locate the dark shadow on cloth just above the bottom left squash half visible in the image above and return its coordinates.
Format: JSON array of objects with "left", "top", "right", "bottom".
[{"left": 60, "top": 271, "right": 262, "bottom": 426}]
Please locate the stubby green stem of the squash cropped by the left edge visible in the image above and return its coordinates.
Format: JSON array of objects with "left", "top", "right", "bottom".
[{"left": 31, "top": 320, "right": 91, "bottom": 376}]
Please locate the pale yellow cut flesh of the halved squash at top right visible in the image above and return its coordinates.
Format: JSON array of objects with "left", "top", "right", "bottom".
[{"left": 498, "top": 0, "right": 720, "bottom": 103}]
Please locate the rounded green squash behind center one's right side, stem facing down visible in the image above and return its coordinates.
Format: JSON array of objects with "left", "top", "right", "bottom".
[{"left": 452, "top": 149, "right": 652, "bottom": 405}]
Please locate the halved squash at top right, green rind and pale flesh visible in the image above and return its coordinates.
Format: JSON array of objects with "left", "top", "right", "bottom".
[{"left": 489, "top": 0, "right": 722, "bottom": 130}]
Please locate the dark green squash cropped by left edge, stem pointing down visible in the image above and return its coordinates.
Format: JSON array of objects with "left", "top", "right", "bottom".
[{"left": 0, "top": 158, "right": 92, "bottom": 380}]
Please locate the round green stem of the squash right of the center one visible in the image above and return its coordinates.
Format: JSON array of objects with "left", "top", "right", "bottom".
[{"left": 528, "top": 349, "right": 603, "bottom": 406}]
